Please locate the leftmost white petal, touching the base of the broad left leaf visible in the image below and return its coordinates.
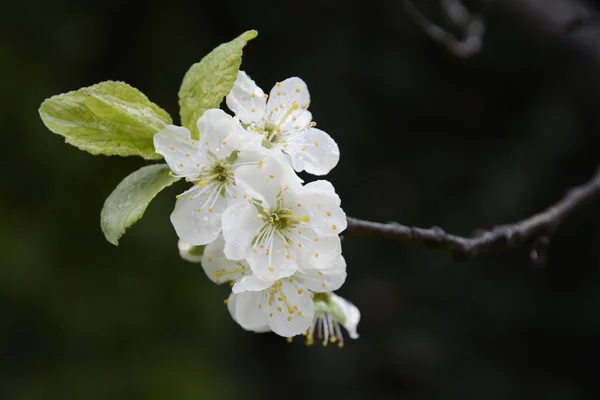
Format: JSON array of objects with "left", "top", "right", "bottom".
[{"left": 154, "top": 125, "right": 207, "bottom": 179}]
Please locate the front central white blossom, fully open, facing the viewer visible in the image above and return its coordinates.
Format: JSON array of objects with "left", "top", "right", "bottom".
[{"left": 223, "top": 158, "right": 347, "bottom": 281}]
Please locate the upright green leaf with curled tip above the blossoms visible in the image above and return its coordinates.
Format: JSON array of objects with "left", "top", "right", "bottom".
[{"left": 179, "top": 31, "right": 258, "bottom": 139}]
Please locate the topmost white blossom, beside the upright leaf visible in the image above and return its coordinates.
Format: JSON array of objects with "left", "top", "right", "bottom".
[{"left": 226, "top": 71, "right": 340, "bottom": 175}]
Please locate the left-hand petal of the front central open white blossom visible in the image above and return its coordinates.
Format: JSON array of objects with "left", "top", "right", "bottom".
[{"left": 222, "top": 202, "right": 262, "bottom": 260}]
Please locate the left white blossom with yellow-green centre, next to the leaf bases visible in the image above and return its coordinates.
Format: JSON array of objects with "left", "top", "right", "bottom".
[{"left": 154, "top": 109, "right": 256, "bottom": 245}]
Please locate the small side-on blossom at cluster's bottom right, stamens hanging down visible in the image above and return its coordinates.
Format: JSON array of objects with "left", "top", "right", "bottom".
[{"left": 305, "top": 293, "right": 360, "bottom": 348}]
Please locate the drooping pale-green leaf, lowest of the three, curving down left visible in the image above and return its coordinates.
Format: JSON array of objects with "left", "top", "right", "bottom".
[{"left": 100, "top": 164, "right": 179, "bottom": 246}]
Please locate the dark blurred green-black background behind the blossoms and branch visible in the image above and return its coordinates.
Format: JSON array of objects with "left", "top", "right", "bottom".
[{"left": 0, "top": 0, "right": 600, "bottom": 400}]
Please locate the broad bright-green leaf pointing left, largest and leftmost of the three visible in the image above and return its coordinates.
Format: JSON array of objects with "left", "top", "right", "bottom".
[{"left": 39, "top": 81, "right": 172, "bottom": 159}]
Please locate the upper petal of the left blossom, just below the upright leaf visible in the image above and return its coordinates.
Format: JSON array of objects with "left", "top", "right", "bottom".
[{"left": 198, "top": 108, "right": 246, "bottom": 160}]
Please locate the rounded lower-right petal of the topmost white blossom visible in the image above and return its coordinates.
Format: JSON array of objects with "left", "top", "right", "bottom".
[{"left": 285, "top": 128, "right": 340, "bottom": 175}]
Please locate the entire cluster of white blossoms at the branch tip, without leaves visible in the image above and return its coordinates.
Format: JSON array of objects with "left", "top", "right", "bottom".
[{"left": 154, "top": 71, "right": 360, "bottom": 347}]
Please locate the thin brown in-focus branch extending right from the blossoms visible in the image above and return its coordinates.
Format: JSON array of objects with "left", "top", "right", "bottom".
[{"left": 346, "top": 168, "right": 600, "bottom": 264}]
